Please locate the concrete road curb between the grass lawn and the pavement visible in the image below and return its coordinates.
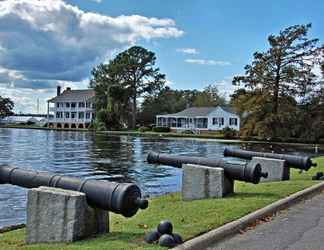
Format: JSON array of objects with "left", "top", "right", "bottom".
[{"left": 172, "top": 182, "right": 324, "bottom": 250}]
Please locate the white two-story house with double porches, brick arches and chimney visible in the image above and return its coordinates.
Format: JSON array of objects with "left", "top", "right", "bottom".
[{"left": 47, "top": 86, "right": 95, "bottom": 129}]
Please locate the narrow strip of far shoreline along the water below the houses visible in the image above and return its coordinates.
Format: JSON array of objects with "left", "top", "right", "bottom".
[{"left": 0, "top": 125, "right": 324, "bottom": 149}]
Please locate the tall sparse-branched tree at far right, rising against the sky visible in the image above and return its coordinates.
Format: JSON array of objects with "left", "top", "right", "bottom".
[{"left": 233, "top": 24, "right": 323, "bottom": 115}]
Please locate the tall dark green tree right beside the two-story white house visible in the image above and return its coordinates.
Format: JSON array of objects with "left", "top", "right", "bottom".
[{"left": 90, "top": 46, "right": 165, "bottom": 128}]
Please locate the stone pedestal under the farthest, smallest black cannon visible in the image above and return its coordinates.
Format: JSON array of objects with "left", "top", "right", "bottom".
[{"left": 250, "top": 157, "right": 290, "bottom": 182}]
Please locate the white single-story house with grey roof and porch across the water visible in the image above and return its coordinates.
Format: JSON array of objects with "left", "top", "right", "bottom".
[{"left": 156, "top": 106, "right": 240, "bottom": 132}]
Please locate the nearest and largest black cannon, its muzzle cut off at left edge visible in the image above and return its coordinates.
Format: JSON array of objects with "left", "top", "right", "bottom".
[{"left": 0, "top": 166, "right": 148, "bottom": 217}]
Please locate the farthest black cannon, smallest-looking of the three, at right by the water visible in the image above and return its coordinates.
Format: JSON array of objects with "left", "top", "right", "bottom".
[{"left": 224, "top": 148, "right": 317, "bottom": 171}]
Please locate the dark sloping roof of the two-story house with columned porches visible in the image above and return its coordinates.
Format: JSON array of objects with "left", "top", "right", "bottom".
[{"left": 48, "top": 89, "right": 95, "bottom": 102}]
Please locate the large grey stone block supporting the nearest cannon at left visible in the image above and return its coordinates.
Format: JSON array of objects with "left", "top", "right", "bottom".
[{"left": 26, "top": 187, "right": 109, "bottom": 244}]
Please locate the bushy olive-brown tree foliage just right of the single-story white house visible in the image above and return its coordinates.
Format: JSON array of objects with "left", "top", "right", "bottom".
[{"left": 230, "top": 89, "right": 299, "bottom": 138}]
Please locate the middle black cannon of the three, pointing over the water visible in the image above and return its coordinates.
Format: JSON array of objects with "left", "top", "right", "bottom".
[{"left": 147, "top": 152, "right": 268, "bottom": 184}]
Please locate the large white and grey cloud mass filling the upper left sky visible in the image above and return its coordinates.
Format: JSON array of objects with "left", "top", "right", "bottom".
[{"left": 0, "top": 0, "right": 184, "bottom": 113}]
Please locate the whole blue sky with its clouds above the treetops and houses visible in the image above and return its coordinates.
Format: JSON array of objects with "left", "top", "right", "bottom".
[{"left": 0, "top": 0, "right": 324, "bottom": 112}]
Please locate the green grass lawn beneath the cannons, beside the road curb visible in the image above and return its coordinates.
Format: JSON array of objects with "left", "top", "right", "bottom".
[{"left": 0, "top": 157, "right": 324, "bottom": 250}]
